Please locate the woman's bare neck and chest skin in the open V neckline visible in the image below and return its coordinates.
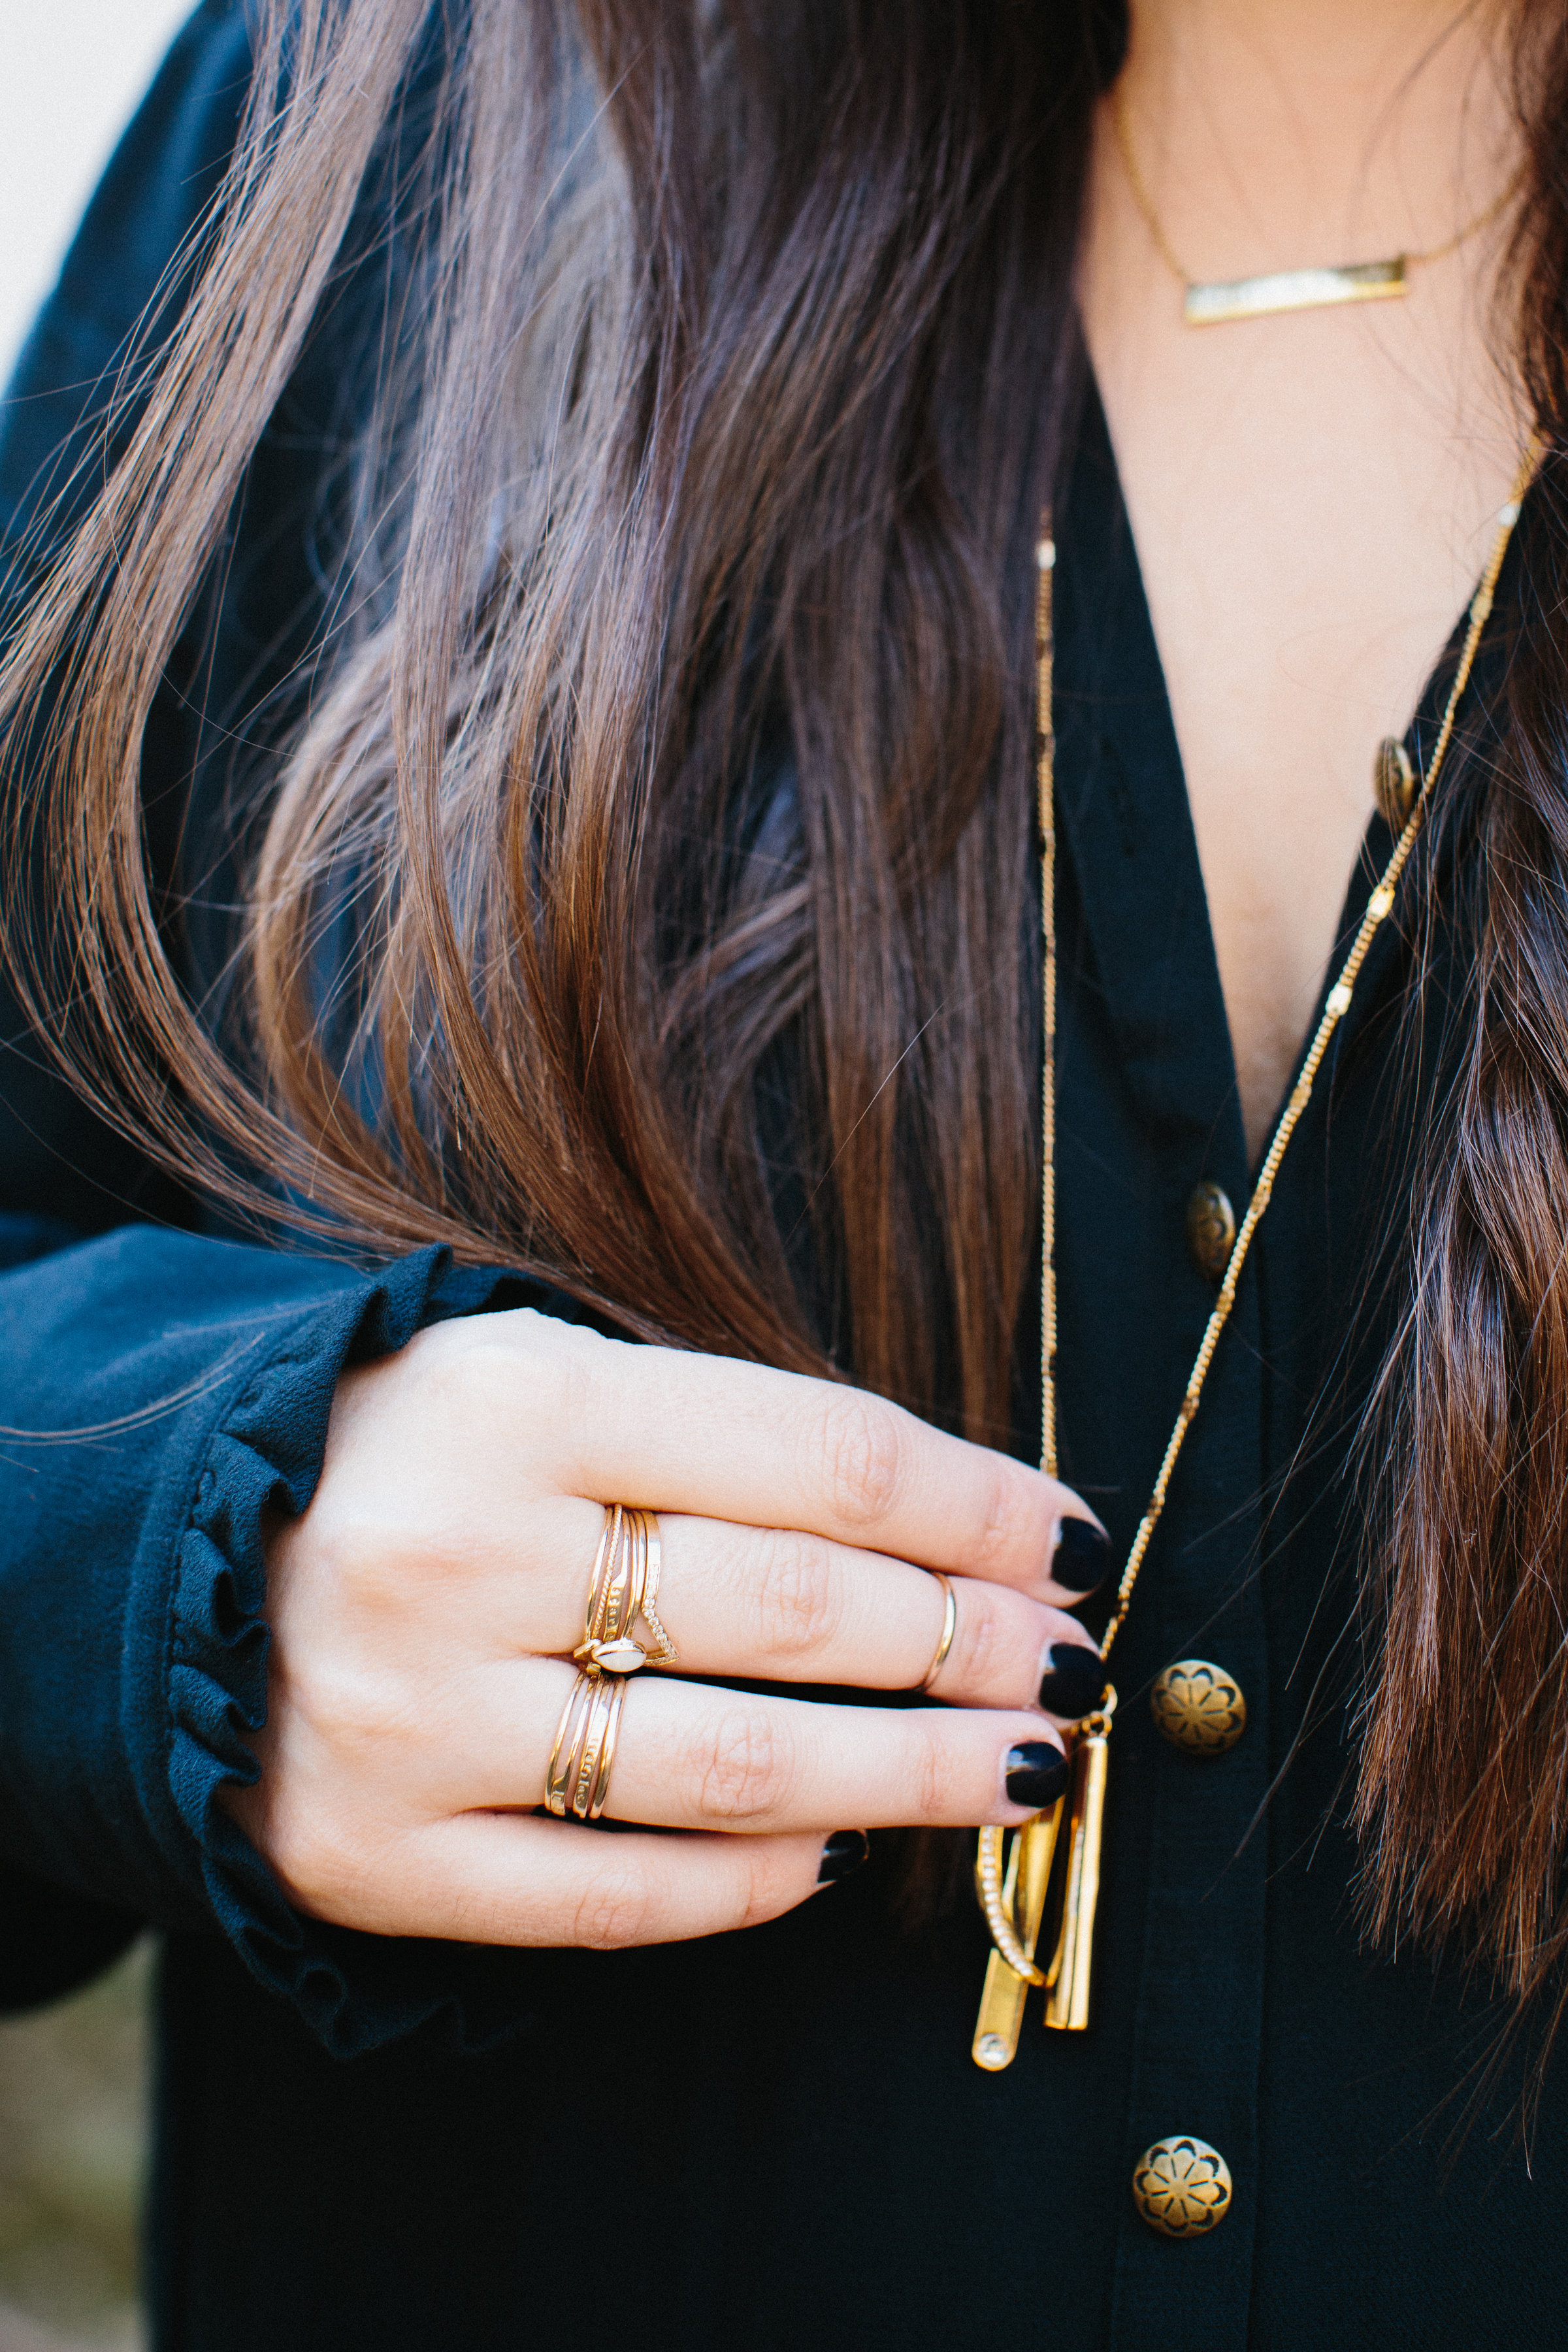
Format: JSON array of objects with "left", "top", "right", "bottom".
[{"left": 1081, "top": 0, "right": 1524, "bottom": 1160}]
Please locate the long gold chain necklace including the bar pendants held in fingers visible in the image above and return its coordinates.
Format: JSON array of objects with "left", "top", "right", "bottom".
[{"left": 971, "top": 440, "right": 1540, "bottom": 2074}]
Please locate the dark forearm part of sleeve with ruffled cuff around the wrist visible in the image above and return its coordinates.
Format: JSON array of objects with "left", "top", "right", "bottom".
[{"left": 0, "top": 1226, "right": 564, "bottom": 2051}]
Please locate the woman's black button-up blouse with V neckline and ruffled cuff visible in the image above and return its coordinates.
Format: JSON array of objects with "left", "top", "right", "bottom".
[{"left": 0, "top": 0, "right": 1568, "bottom": 2352}]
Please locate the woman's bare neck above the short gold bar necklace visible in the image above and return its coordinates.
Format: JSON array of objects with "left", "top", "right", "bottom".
[{"left": 1121, "top": 0, "right": 1516, "bottom": 278}]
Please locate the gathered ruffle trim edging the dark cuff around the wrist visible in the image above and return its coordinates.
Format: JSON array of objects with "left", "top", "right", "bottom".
[{"left": 167, "top": 1249, "right": 576, "bottom": 2058}]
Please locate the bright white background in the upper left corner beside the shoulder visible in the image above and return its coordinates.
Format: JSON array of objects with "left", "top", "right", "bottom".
[{"left": 0, "top": 0, "right": 195, "bottom": 381}]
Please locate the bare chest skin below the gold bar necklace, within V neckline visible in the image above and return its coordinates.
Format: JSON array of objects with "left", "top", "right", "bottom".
[{"left": 1084, "top": 142, "right": 1521, "bottom": 1157}]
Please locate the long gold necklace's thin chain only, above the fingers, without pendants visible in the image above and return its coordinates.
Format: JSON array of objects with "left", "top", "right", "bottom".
[{"left": 1034, "top": 440, "right": 1542, "bottom": 1658}]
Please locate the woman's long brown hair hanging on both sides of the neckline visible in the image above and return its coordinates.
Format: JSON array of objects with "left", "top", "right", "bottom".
[{"left": 0, "top": 0, "right": 1568, "bottom": 2023}]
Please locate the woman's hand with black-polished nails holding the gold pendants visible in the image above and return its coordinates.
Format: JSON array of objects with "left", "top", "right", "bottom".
[{"left": 233, "top": 1313, "right": 1105, "bottom": 1948}]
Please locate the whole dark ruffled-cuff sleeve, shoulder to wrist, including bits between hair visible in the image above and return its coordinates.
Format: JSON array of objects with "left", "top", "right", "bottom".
[{"left": 0, "top": 0, "right": 574, "bottom": 2051}]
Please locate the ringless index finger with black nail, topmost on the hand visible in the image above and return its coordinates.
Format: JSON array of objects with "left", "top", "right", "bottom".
[{"left": 512, "top": 1324, "right": 1109, "bottom": 1602}]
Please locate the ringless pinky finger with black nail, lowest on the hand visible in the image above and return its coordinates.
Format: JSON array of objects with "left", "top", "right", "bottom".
[{"left": 397, "top": 1814, "right": 846, "bottom": 1952}]
